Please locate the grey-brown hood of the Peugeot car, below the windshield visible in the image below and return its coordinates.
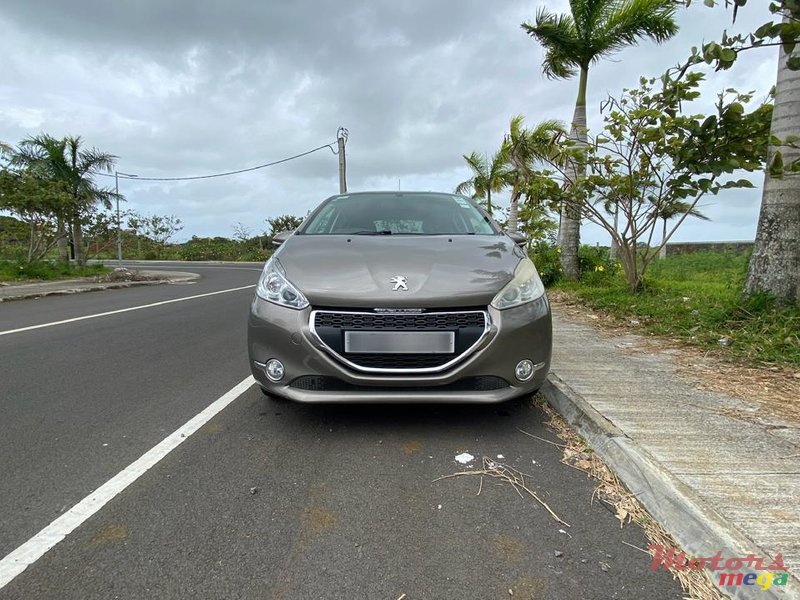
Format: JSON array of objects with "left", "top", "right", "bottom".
[{"left": 276, "top": 235, "right": 525, "bottom": 308}]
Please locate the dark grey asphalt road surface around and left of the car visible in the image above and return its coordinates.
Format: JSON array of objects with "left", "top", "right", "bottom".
[{"left": 0, "top": 265, "right": 682, "bottom": 600}]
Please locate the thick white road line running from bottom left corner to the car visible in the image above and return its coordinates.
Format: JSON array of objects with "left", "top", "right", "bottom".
[{"left": 0, "top": 375, "right": 255, "bottom": 589}]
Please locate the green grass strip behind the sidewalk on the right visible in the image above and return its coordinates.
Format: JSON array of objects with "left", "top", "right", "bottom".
[{"left": 553, "top": 252, "right": 800, "bottom": 366}]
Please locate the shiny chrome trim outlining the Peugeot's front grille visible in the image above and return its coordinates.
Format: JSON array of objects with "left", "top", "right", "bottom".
[{"left": 308, "top": 309, "right": 492, "bottom": 375}]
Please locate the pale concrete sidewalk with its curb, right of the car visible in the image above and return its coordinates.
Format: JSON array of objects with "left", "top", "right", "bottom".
[{"left": 542, "top": 309, "right": 800, "bottom": 598}]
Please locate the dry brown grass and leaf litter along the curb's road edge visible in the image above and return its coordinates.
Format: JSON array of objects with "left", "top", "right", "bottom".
[{"left": 538, "top": 400, "right": 725, "bottom": 600}]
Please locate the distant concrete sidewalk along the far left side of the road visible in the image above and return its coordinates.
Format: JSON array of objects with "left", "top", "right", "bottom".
[{"left": 0, "top": 271, "right": 200, "bottom": 302}]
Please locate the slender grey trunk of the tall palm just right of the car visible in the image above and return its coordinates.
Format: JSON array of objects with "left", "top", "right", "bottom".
[{"left": 558, "top": 68, "right": 589, "bottom": 280}]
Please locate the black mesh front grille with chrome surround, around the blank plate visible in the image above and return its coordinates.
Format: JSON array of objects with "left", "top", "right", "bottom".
[{"left": 311, "top": 310, "right": 489, "bottom": 373}]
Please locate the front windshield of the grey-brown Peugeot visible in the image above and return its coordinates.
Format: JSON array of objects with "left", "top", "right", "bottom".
[{"left": 298, "top": 192, "right": 498, "bottom": 235}]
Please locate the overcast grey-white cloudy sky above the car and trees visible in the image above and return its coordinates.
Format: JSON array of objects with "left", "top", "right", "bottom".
[{"left": 0, "top": 0, "right": 777, "bottom": 243}]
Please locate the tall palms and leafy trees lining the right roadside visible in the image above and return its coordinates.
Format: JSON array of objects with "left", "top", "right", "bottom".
[{"left": 456, "top": 0, "right": 800, "bottom": 312}]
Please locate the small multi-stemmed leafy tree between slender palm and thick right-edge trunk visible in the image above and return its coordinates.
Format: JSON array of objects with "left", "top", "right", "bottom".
[{"left": 564, "top": 73, "right": 772, "bottom": 291}]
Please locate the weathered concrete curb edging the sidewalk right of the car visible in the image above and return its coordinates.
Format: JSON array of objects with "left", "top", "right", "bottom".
[{"left": 540, "top": 373, "right": 800, "bottom": 600}]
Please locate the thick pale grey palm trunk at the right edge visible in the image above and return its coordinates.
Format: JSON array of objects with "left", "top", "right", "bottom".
[{"left": 744, "top": 43, "right": 800, "bottom": 305}]
